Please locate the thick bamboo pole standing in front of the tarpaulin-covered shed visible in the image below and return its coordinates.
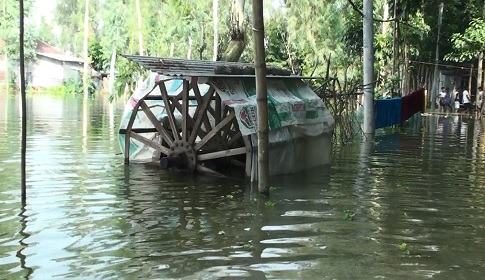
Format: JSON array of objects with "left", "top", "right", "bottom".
[{"left": 253, "top": 0, "right": 269, "bottom": 194}]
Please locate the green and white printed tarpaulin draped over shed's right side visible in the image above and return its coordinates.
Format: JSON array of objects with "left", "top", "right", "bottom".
[{"left": 212, "top": 78, "right": 334, "bottom": 135}]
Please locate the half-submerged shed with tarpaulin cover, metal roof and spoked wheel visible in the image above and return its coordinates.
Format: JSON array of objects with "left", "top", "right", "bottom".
[{"left": 119, "top": 56, "right": 334, "bottom": 179}]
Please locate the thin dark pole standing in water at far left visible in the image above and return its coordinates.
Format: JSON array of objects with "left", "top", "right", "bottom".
[{"left": 19, "top": 0, "right": 27, "bottom": 203}]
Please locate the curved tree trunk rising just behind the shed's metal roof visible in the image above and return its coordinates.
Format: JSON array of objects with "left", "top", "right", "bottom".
[{"left": 221, "top": 0, "right": 246, "bottom": 62}]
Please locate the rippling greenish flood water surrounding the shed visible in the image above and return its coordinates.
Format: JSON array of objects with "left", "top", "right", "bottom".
[{"left": 0, "top": 94, "right": 485, "bottom": 279}]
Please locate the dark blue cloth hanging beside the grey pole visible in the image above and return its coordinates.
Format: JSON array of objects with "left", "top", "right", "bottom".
[{"left": 375, "top": 98, "right": 401, "bottom": 129}]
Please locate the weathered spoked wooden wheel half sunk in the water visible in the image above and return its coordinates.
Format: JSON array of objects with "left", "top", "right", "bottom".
[{"left": 120, "top": 76, "right": 251, "bottom": 176}]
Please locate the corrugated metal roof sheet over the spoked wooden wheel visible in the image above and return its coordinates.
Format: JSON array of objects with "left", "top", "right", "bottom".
[{"left": 123, "top": 55, "right": 318, "bottom": 79}]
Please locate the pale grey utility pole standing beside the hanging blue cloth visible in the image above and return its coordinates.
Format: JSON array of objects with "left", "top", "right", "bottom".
[{"left": 363, "top": 0, "right": 375, "bottom": 134}]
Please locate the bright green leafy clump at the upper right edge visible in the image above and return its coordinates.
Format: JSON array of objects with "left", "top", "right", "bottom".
[{"left": 445, "top": 18, "right": 485, "bottom": 61}]
